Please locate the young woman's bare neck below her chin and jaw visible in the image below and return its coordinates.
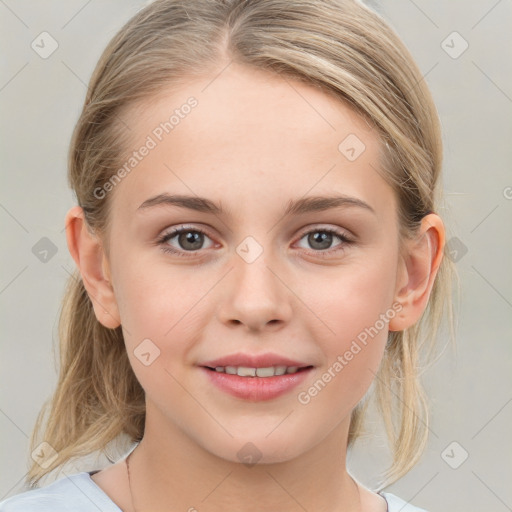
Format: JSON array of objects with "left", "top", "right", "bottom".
[{"left": 129, "top": 404, "right": 361, "bottom": 512}]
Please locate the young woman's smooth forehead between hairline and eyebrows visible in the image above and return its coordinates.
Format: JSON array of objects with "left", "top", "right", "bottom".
[{"left": 111, "top": 64, "right": 393, "bottom": 220}]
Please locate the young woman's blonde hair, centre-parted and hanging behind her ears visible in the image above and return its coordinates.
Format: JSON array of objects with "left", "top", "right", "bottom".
[{"left": 27, "top": 0, "right": 456, "bottom": 487}]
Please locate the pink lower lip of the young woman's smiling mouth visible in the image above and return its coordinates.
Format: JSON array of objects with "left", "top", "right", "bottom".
[{"left": 201, "top": 366, "right": 313, "bottom": 402}]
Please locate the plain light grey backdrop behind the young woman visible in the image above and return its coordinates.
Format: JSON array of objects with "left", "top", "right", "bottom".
[{"left": 0, "top": 0, "right": 512, "bottom": 512}]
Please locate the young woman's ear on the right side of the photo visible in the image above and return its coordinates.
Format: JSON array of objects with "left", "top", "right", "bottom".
[{"left": 389, "top": 213, "right": 445, "bottom": 331}]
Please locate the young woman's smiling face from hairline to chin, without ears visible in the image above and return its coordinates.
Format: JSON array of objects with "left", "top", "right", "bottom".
[{"left": 101, "top": 64, "right": 400, "bottom": 462}]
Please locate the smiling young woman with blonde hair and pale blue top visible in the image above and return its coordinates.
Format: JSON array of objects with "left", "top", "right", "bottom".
[{"left": 0, "top": 0, "right": 452, "bottom": 512}]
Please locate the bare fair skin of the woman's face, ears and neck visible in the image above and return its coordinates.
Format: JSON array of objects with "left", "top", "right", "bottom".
[{"left": 66, "top": 64, "right": 445, "bottom": 512}]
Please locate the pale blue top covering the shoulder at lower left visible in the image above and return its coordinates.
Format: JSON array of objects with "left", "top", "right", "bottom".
[{"left": 0, "top": 471, "right": 121, "bottom": 512}]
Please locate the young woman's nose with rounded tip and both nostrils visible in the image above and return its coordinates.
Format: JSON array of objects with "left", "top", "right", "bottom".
[{"left": 217, "top": 247, "right": 293, "bottom": 331}]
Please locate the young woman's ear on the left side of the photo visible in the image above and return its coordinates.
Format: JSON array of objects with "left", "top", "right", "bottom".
[{"left": 65, "top": 206, "right": 121, "bottom": 329}]
